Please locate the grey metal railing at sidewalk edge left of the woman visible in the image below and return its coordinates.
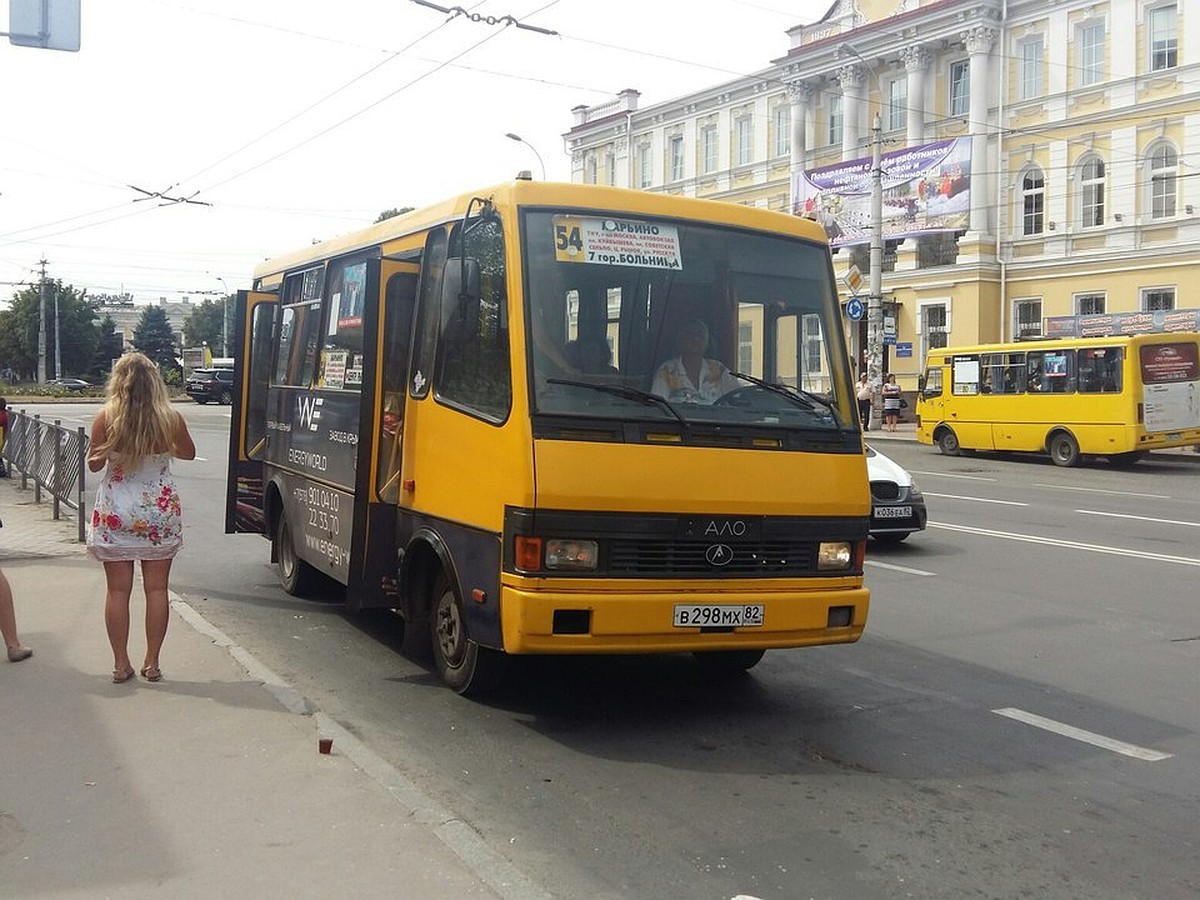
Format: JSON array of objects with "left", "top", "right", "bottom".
[{"left": 0, "top": 409, "right": 88, "bottom": 542}]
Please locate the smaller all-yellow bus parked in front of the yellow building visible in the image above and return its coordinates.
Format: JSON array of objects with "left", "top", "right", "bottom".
[{"left": 917, "top": 332, "right": 1200, "bottom": 466}]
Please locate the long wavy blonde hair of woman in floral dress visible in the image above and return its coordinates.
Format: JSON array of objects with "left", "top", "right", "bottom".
[{"left": 104, "top": 353, "right": 178, "bottom": 468}]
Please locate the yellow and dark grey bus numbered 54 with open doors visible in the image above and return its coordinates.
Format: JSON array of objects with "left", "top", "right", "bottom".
[{"left": 226, "top": 180, "right": 870, "bottom": 694}]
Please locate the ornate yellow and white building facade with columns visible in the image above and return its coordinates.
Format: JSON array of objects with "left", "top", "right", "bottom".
[{"left": 564, "top": 0, "right": 1200, "bottom": 390}]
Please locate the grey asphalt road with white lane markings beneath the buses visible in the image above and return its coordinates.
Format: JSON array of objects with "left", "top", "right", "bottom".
[{"left": 21, "top": 404, "right": 1200, "bottom": 900}]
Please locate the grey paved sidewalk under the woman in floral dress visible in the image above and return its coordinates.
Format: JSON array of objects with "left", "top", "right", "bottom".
[{"left": 0, "top": 481, "right": 535, "bottom": 900}]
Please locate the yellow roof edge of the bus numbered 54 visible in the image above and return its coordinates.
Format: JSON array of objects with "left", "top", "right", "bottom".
[{"left": 254, "top": 179, "right": 826, "bottom": 286}]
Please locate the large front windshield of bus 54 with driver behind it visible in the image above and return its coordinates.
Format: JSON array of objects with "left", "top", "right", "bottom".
[{"left": 522, "top": 210, "right": 854, "bottom": 430}]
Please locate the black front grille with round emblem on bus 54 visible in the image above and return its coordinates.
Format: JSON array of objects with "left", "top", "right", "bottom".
[{"left": 608, "top": 539, "right": 817, "bottom": 578}]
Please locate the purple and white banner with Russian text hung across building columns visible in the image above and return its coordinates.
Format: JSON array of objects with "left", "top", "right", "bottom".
[{"left": 792, "top": 138, "right": 971, "bottom": 247}]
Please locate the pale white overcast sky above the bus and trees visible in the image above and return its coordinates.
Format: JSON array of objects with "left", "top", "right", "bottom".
[{"left": 0, "top": 0, "right": 832, "bottom": 305}]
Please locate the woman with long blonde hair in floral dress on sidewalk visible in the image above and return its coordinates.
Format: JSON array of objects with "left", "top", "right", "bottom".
[{"left": 88, "top": 353, "right": 196, "bottom": 684}]
